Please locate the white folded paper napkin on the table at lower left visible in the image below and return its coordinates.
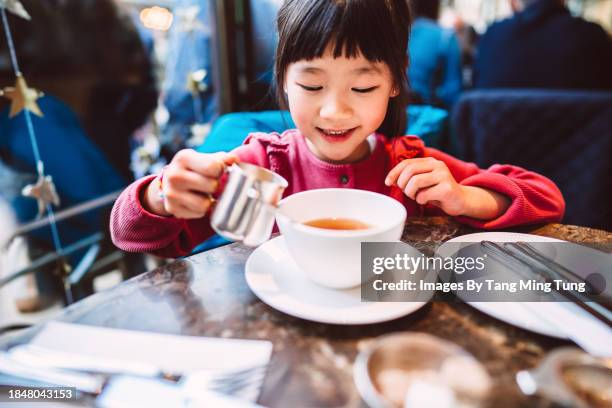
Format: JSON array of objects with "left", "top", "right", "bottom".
[{"left": 30, "top": 321, "right": 272, "bottom": 401}]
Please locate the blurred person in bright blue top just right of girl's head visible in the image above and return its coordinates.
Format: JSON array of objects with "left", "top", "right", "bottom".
[{"left": 408, "top": 0, "right": 462, "bottom": 108}]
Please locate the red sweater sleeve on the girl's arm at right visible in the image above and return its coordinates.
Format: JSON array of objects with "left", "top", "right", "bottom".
[{"left": 425, "top": 148, "right": 565, "bottom": 229}]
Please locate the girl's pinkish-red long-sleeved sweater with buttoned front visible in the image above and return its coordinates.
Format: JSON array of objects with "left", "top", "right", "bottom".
[{"left": 110, "top": 129, "right": 565, "bottom": 257}]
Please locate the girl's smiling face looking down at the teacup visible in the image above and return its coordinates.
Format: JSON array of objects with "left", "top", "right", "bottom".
[{"left": 285, "top": 47, "right": 397, "bottom": 163}]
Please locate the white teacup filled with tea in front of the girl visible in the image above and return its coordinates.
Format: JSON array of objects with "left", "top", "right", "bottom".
[{"left": 276, "top": 188, "right": 406, "bottom": 289}]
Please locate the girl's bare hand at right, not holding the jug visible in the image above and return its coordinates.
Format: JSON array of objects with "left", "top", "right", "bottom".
[{"left": 385, "top": 157, "right": 466, "bottom": 216}]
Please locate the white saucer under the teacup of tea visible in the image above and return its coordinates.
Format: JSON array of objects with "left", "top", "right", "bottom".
[{"left": 245, "top": 236, "right": 427, "bottom": 325}]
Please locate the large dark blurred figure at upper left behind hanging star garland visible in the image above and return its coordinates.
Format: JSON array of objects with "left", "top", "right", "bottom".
[{"left": 0, "top": 0, "right": 157, "bottom": 181}]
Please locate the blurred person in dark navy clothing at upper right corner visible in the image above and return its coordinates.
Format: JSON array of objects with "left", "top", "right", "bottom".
[{"left": 474, "top": 0, "right": 612, "bottom": 89}]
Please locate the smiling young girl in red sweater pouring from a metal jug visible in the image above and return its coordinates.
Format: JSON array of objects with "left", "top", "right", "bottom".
[{"left": 111, "top": 0, "right": 564, "bottom": 257}]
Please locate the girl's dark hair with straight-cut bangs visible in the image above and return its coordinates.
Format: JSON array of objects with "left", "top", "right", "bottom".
[{"left": 275, "top": 0, "right": 411, "bottom": 137}]
